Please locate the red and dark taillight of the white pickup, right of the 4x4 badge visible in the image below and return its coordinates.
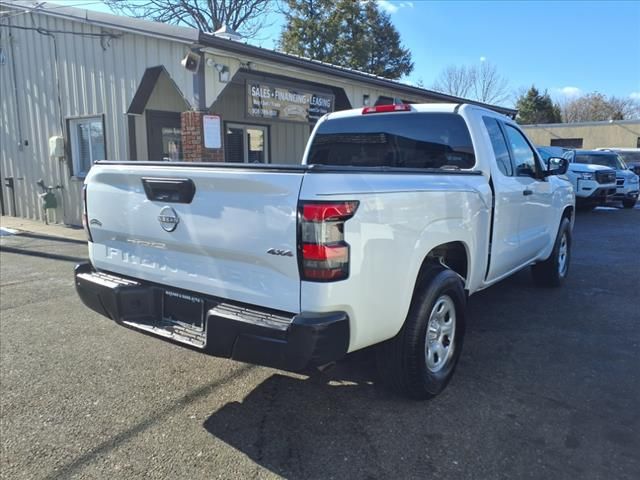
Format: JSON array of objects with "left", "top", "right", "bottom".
[{"left": 298, "top": 201, "right": 358, "bottom": 282}]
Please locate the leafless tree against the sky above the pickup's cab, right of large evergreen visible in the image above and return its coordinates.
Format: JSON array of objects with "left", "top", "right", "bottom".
[{"left": 432, "top": 62, "right": 509, "bottom": 103}]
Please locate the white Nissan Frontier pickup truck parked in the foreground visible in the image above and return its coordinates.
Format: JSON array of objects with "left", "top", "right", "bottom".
[{"left": 75, "top": 104, "right": 575, "bottom": 398}]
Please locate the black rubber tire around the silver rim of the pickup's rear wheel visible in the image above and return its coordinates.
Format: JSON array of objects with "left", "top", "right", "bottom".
[{"left": 376, "top": 265, "right": 466, "bottom": 400}]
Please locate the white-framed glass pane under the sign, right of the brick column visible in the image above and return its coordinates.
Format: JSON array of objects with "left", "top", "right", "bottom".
[{"left": 225, "top": 123, "right": 269, "bottom": 163}]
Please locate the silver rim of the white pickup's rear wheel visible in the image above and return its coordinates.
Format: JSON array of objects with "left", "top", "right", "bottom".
[{"left": 425, "top": 295, "right": 456, "bottom": 373}]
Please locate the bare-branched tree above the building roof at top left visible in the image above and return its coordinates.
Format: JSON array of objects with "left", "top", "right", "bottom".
[{"left": 104, "top": 0, "right": 276, "bottom": 38}]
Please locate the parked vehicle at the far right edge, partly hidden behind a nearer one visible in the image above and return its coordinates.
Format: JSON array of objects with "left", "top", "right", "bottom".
[{"left": 571, "top": 149, "right": 640, "bottom": 208}]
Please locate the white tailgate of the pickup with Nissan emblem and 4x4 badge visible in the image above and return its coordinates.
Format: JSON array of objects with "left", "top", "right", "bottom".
[{"left": 85, "top": 162, "right": 304, "bottom": 313}]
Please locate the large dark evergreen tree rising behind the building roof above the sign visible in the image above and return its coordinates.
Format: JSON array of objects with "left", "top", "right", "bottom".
[{"left": 279, "top": 0, "right": 413, "bottom": 79}]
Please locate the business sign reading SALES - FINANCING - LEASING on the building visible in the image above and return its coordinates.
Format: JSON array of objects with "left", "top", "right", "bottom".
[{"left": 247, "top": 82, "right": 335, "bottom": 123}]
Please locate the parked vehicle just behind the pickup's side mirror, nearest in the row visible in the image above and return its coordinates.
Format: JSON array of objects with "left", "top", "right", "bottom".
[{"left": 537, "top": 146, "right": 616, "bottom": 209}]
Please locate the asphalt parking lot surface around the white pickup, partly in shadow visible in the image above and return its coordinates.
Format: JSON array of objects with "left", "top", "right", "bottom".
[{"left": 0, "top": 209, "right": 640, "bottom": 479}]
